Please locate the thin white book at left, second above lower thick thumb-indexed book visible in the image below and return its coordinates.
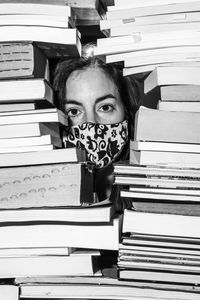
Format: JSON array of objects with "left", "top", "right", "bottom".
[{"left": 0, "top": 134, "right": 62, "bottom": 149}]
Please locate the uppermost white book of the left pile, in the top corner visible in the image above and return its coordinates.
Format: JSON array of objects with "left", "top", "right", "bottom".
[{"left": 0, "top": 2, "right": 71, "bottom": 18}]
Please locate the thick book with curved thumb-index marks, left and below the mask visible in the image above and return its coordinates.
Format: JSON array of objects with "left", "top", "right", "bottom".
[{"left": 0, "top": 162, "right": 94, "bottom": 209}]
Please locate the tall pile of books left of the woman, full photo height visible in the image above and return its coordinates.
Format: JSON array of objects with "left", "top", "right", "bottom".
[{"left": 0, "top": 1, "right": 122, "bottom": 300}]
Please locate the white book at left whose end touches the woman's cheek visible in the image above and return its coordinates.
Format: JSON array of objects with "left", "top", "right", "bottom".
[{"left": 0, "top": 108, "right": 68, "bottom": 126}]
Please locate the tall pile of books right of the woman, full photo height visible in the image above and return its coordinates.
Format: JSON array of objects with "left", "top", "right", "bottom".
[{"left": 99, "top": 0, "right": 200, "bottom": 299}]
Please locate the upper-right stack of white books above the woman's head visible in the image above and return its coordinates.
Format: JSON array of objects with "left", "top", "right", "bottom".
[{"left": 95, "top": 0, "right": 200, "bottom": 76}]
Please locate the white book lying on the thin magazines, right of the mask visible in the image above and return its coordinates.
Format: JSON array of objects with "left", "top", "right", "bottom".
[{"left": 130, "top": 150, "right": 200, "bottom": 169}]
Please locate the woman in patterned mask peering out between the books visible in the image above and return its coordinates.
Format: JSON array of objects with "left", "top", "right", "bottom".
[{"left": 54, "top": 51, "right": 138, "bottom": 200}]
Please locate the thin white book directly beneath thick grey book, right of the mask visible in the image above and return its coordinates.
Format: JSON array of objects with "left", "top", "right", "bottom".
[{"left": 130, "top": 140, "right": 200, "bottom": 153}]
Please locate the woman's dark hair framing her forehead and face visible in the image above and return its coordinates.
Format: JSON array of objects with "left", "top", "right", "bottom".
[{"left": 53, "top": 57, "right": 139, "bottom": 138}]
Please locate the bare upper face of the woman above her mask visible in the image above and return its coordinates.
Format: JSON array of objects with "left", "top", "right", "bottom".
[{"left": 65, "top": 68, "right": 125, "bottom": 126}]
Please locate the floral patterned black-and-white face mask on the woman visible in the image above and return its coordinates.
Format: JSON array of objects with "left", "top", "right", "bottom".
[{"left": 64, "top": 120, "right": 128, "bottom": 168}]
